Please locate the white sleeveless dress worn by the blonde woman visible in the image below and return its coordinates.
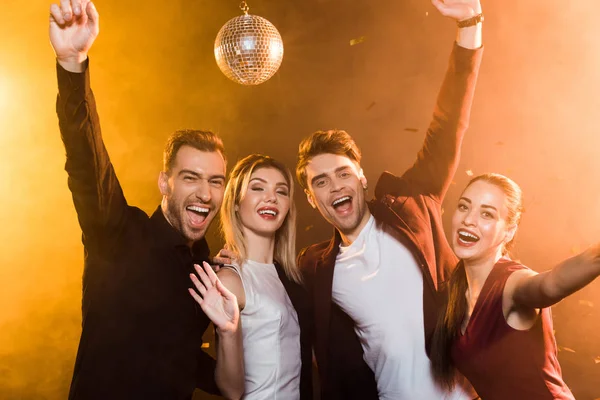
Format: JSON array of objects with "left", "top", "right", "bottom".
[{"left": 226, "top": 260, "right": 302, "bottom": 400}]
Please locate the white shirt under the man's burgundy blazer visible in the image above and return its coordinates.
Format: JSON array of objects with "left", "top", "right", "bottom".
[{"left": 332, "top": 216, "right": 469, "bottom": 400}]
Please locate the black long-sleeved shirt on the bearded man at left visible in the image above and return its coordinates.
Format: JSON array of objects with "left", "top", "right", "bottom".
[{"left": 57, "top": 62, "right": 217, "bottom": 400}]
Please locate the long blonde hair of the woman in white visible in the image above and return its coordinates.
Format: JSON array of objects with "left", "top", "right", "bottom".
[{"left": 221, "top": 154, "right": 302, "bottom": 283}]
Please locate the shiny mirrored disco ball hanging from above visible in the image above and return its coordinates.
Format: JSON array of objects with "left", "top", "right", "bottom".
[{"left": 215, "top": 13, "right": 283, "bottom": 85}]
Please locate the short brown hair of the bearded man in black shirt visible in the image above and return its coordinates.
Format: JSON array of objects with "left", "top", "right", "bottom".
[{"left": 163, "top": 129, "right": 227, "bottom": 172}]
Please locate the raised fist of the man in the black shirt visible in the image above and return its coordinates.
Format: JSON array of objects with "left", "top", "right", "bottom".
[{"left": 50, "top": 0, "right": 100, "bottom": 72}]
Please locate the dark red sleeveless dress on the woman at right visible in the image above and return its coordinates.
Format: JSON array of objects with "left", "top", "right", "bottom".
[{"left": 452, "top": 258, "right": 574, "bottom": 400}]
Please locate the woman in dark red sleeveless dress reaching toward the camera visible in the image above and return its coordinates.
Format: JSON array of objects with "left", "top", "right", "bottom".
[{"left": 431, "top": 174, "right": 600, "bottom": 400}]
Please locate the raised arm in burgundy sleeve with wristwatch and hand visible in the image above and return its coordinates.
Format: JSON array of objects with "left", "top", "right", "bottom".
[{"left": 403, "top": 0, "right": 483, "bottom": 201}]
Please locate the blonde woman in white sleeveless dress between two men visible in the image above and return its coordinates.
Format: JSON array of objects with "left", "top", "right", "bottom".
[{"left": 191, "top": 154, "right": 312, "bottom": 400}]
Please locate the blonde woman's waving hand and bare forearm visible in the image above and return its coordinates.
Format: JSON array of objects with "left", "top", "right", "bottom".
[{"left": 189, "top": 262, "right": 244, "bottom": 399}]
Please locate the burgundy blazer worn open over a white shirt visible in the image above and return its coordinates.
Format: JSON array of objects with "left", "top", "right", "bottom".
[{"left": 298, "top": 44, "right": 483, "bottom": 399}]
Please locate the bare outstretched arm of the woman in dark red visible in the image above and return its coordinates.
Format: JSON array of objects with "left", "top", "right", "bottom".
[{"left": 505, "top": 243, "right": 600, "bottom": 309}]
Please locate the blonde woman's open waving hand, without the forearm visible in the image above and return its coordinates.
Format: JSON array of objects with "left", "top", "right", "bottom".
[{"left": 189, "top": 262, "right": 240, "bottom": 334}]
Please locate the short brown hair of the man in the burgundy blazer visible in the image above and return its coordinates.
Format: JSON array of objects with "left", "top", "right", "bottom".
[{"left": 296, "top": 129, "right": 362, "bottom": 189}]
